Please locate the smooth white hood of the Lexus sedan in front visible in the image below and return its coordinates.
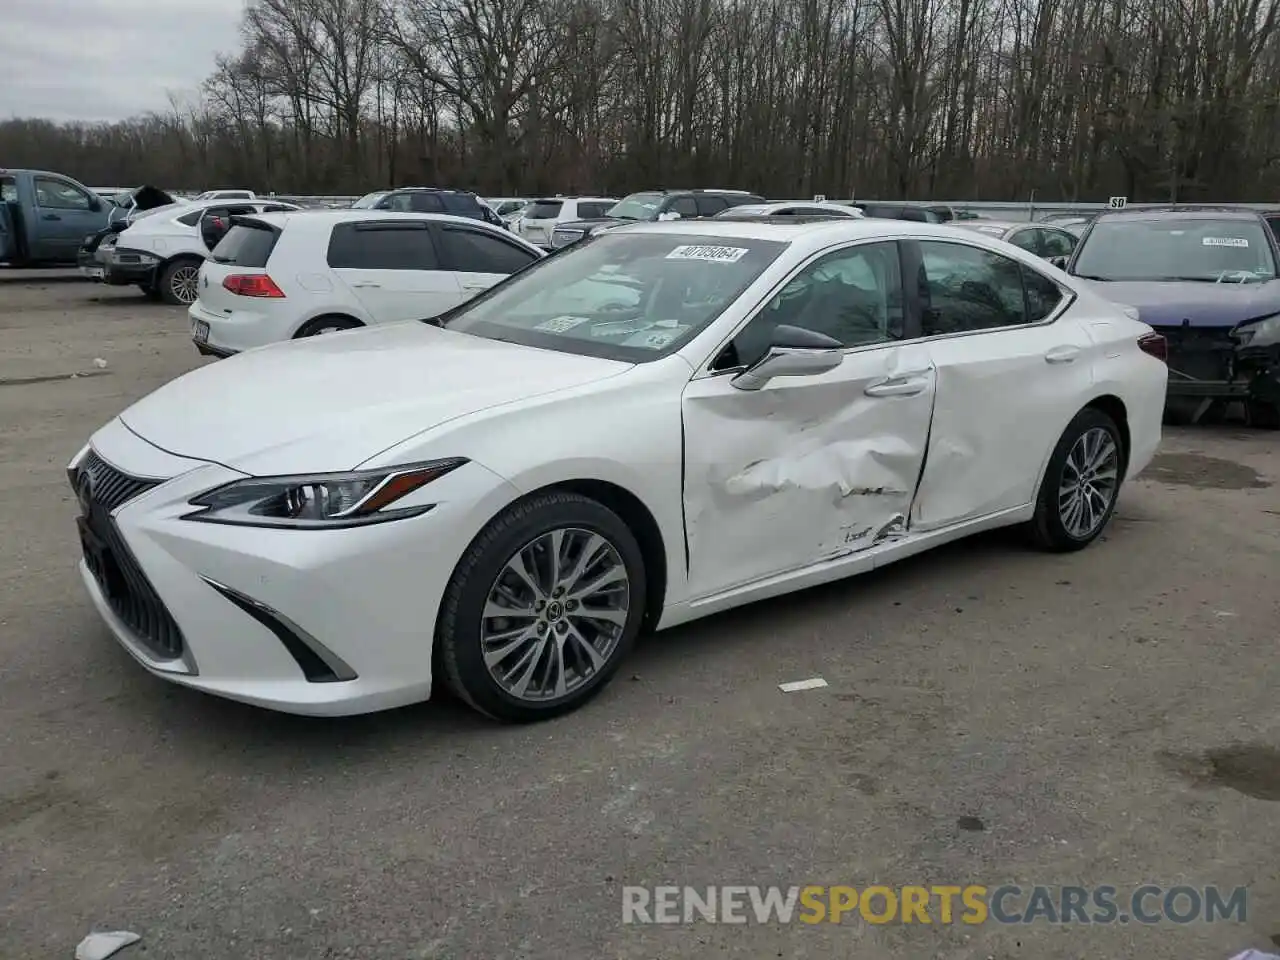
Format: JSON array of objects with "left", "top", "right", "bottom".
[{"left": 120, "top": 321, "right": 632, "bottom": 476}]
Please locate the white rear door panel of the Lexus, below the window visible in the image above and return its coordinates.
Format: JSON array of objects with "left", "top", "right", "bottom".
[{"left": 911, "top": 323, "right": 1100, "bottom": 531}]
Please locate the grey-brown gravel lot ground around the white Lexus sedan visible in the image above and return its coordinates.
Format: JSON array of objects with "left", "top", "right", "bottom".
[{"left": 0, "top": 273, "right": 1280, "bottom": 960}]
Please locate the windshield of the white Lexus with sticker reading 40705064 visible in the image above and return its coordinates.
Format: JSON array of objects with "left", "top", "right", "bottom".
[{"left": 442, "top": 230, "right": 787, "bottom": 362}]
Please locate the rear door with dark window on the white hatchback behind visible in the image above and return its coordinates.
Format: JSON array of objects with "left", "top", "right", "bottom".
[{"left": 328, "top": 220, "right": 463, "bottom": 323}]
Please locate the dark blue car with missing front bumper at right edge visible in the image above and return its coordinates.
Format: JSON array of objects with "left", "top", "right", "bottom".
[{"left": 1065, "top": 207, "right": 1280, "bottom": 429}]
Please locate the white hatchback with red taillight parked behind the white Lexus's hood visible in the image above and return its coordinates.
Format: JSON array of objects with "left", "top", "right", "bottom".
[{"left": 188, "top": 210, "right": 544, "bottom": 357}]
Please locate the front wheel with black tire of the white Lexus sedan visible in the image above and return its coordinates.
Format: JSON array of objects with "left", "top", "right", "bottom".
[{"left": 435, "top": 492, "right": 648, "bottom": 723}]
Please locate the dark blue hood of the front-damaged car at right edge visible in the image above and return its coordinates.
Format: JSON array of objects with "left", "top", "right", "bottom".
[{"left": 1089, "top": 280, "right": 1280, "bottom": 328}]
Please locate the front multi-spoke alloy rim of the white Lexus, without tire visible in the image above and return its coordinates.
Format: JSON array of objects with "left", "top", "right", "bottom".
[{"left": 480, "top": 527, "right": 631, "bottom": 701}]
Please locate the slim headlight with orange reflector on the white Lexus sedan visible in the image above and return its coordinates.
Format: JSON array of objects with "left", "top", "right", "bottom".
[{"left": 183, "top": 458, "right": 467, "bottom": 530}]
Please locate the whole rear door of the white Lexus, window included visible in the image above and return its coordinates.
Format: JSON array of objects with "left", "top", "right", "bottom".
[{"left": 906, "top": 241, "right": 1093, "bottom": 530}]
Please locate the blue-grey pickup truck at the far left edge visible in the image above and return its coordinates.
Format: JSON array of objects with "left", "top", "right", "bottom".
[{"left": 0, "top": 169, "right": 115, "bottom": 265}]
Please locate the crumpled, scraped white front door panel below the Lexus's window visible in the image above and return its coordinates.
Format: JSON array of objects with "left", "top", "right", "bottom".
[{"left": 682, "top": 344, "right": 934, "bottom": 598}]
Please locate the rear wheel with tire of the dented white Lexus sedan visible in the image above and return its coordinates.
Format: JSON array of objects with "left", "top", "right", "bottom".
[{"left": 1029, "top": 407, "right": 1126, "bottom": 553}]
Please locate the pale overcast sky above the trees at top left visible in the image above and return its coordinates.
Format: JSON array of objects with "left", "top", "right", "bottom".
[{"left": 0, "top": 0, "right": 244, "bottom": 120}]
